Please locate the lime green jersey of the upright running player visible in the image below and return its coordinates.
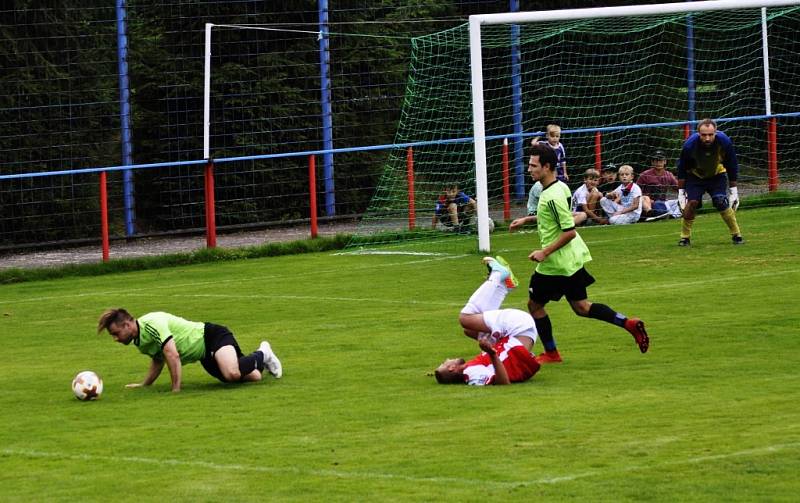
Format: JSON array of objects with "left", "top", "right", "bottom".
[{"left": 536, "top": 181, "right": 592, "bottom": 276}]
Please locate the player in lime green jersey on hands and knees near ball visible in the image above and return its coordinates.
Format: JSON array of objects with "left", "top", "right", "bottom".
[{"left": 97, "top": 308, "right": 283, "bottom": 392}]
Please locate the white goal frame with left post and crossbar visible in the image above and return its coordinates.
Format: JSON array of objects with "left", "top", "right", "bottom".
[{"left": 469, "top": 0, "right": 800, "bottom": 252}]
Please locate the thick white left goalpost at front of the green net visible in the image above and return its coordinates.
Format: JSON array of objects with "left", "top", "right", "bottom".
[{"left": 469, "top": 17, "right": 491, "bottom": 253}]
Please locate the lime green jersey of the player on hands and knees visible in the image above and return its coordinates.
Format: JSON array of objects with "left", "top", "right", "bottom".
[{"left": 133, "top": 312, "right": 206, "bottom": 365}]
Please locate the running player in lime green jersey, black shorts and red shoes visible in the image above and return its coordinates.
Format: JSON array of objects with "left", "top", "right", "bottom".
[{"left": 528, "top": 144, "right": 650, "bottom": 363}]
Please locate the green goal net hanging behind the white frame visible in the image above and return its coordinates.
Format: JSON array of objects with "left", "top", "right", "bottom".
[{"left": 350, "top": 1, "right": 800, "bottom": 251}]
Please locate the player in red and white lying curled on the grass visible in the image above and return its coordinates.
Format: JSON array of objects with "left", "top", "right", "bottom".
[{"left": 434, "top": 257, "right": 539, "bottom": 386}]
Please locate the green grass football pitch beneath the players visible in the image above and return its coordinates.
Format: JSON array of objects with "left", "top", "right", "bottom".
[{"left": 0, "top": 206, "right": 800, "bottom": 501}]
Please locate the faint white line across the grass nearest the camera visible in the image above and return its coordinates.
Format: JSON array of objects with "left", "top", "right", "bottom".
[{"left": 0, "top": 443, "right": 800, "bottom": 488}]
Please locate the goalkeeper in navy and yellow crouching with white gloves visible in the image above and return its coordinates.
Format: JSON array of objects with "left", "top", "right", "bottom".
[{"left": 678, "top": 119, "right": 744, "bottom": 246}]
